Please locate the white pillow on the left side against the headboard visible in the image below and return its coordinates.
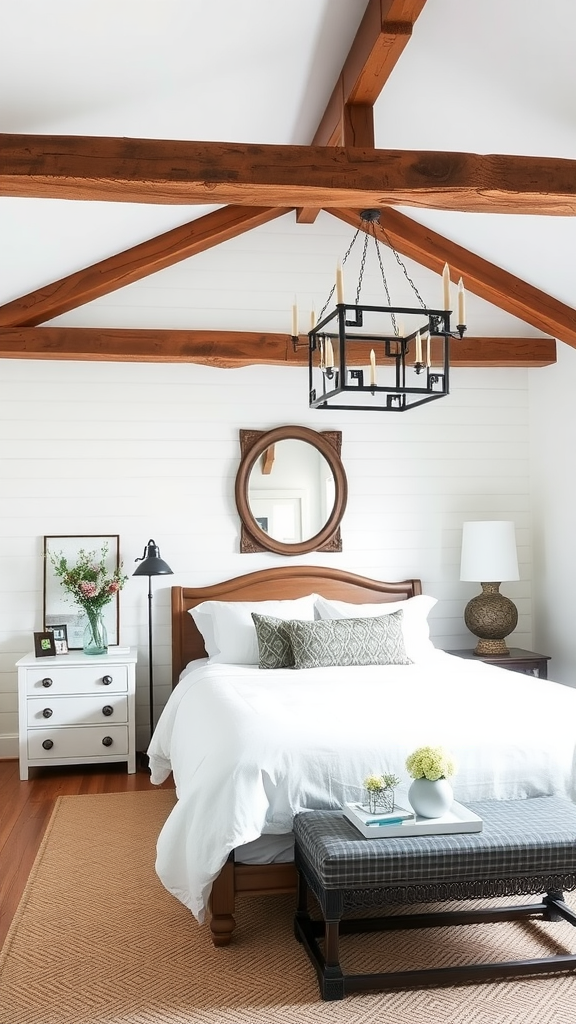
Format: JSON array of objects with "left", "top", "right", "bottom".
[{"left": 190, "top": 594, "right": 318, "bottom": 665}]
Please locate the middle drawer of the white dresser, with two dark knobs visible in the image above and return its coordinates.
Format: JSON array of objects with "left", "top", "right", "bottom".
[{"left": 27, "top": 692, "right": 128, "bottom": 729}]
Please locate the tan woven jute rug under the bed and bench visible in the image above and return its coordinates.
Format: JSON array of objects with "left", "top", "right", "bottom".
[{"left": 0, "top": 791, "right": 576, "bottom": 1024}]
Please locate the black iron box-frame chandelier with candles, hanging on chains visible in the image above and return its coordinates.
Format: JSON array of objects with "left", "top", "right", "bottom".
[{"left": 292, "top": 210, "right": 466, "bottom": 413}]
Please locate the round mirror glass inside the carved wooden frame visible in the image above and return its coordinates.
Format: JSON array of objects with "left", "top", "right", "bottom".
[{"left": 248, "top": 438, "right": 335, "bottom": 544}]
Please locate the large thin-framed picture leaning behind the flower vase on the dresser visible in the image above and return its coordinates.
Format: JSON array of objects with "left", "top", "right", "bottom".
[{"left": 44, "top": 534, "right": 120, "bottom": 650}]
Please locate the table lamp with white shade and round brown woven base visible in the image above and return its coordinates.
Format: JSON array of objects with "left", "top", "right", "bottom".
[{"left": 460, "top": 519, "right": 520, "bottom": 655}]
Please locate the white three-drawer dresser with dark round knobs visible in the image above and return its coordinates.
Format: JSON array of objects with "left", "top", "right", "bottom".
[{"left": 16, "top": 648, "right": 137, "bottom": 779}]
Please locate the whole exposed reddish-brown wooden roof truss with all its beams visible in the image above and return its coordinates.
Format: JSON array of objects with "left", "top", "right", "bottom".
[{"left": 0, "top": 0, "right": 576, "bottom": 366}]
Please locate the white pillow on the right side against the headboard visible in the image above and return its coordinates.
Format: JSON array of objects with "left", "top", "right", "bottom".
[{"left": 316, "top": 594, "right": 437, "bottom": 662}]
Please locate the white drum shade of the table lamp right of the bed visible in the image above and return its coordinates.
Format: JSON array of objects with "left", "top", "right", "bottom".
[{"left": 460, "top": 520, "right": 520, "bottom": 583}]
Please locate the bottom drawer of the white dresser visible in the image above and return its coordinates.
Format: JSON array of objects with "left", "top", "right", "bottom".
[{"left": 28, "top": 725, "right": 128, "bottom": 762}]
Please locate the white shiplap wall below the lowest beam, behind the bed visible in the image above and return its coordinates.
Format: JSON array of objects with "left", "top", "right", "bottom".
[{"left": 0, "top": 359, "right": 532, "bottom": 756}]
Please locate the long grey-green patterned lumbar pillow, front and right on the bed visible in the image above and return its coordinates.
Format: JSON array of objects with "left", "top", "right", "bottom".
[{"left": 286, "top": 611, "right": 412, "bottom": 669}]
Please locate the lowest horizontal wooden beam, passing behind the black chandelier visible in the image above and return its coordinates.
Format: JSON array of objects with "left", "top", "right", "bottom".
[{"left": 0, "top": 327, "right": 556, "bottom": 368}]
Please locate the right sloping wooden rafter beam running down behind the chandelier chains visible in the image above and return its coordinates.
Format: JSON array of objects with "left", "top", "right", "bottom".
[{"left": 329, "top": 209, "right": 576, "bottom": 348}]
